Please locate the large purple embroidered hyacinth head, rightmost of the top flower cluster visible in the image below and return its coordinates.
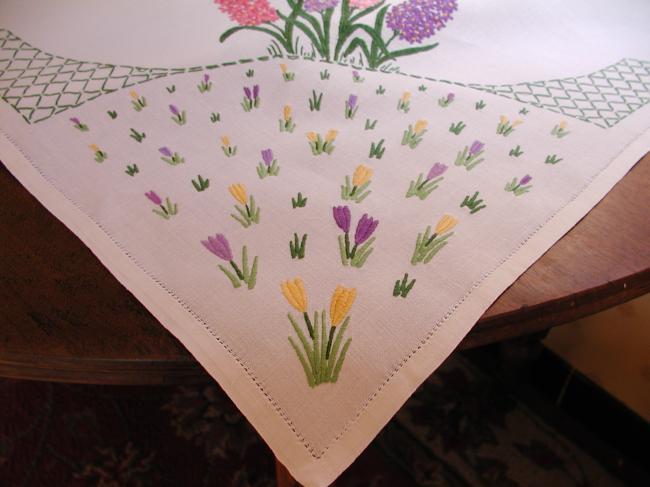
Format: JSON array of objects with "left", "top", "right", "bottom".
[{"left": 386, "top": 0, "right": 458, "bottom": 44}]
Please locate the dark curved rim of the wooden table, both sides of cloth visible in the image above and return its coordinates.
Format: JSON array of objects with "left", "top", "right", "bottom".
[{"left": 0, "top": 270, "right": 650, "bottom": 385}]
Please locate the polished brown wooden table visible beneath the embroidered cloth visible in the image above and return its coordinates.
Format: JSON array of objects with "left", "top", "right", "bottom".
[{"left": 0, "top": 154, "right": 650, "bottom": 384}]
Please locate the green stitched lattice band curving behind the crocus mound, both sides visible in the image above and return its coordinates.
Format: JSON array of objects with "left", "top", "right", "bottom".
[{"left": 0, "top": 29, "right": 650, "bottom": 128}]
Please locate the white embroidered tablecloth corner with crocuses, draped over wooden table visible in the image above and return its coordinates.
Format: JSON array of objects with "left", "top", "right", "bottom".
[{"left": 0, "top": 0, "right": 650, "bottom": 486}]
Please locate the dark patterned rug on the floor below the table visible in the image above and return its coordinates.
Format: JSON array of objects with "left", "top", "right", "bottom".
[{"left": 0, "top": 356, "right": 622, "bottom": 487}]
